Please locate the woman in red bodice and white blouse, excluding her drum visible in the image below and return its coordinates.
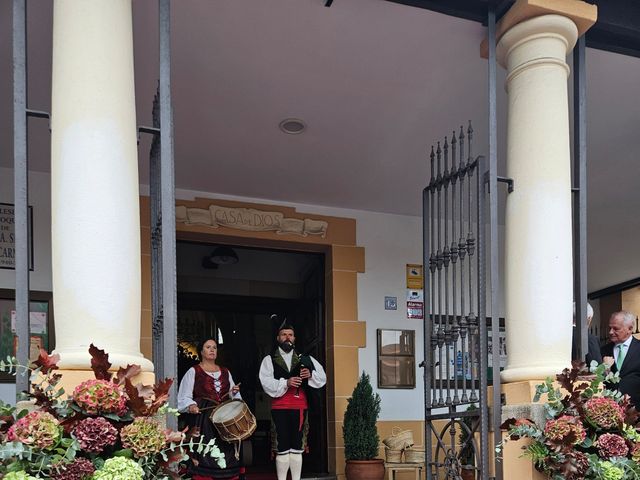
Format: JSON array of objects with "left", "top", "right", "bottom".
[{"left": 178, "top": 339, "right": 241, "bottom": 480}]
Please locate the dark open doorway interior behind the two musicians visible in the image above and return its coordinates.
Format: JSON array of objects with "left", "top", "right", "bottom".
[{"left": 177, "top": 242, "right": 327, "bottom": 478}]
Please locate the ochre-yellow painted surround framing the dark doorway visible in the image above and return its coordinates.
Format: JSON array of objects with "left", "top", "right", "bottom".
[{"left": 140, "top": 197, "right": 366, "bottom": 479}]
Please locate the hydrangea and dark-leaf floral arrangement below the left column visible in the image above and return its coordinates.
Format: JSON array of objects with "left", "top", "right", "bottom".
[{"left": 0, "top": 345, "right": 225, "bottom": 480}]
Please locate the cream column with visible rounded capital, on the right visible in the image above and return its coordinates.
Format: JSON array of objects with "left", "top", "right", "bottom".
[{"left": 497, "top": 15, "right": 578, "bottom": 382}]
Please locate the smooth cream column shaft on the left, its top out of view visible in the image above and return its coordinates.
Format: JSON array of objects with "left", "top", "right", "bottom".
[{"left": 51, "top": 0, "right": 153, "bottom": 371}]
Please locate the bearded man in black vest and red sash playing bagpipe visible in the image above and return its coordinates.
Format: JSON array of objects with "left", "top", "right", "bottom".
[{"left": 259, "top": 315, "right": 327, "bottom": 480}]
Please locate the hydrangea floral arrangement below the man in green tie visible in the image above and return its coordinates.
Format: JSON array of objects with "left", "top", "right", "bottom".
[{"left": 499, "top": 362, "right": 640, "bottom": 480}]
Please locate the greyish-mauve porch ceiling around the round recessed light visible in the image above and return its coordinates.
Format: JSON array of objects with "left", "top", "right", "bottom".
[{"left": 0, "top": 0, "right": 640, "bottom": 290}]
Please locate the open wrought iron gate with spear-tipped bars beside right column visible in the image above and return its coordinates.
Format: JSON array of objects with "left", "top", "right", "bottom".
[{"left": 423, "top": 123, "right": 497, "bottom": 480}]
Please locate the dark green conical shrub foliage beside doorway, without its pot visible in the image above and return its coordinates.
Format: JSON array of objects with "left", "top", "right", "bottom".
[{"left": 342, "top": 372, "right": 380, "bottom": 460}]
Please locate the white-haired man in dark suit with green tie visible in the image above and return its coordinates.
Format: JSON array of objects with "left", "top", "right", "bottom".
[{"left": 602, "top": 311, "right": 640, "bottom": 408}]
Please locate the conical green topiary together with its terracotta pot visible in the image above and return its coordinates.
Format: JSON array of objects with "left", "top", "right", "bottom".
[{"left": 342, "top": 372, "right": 384, "bottom": 480}]
